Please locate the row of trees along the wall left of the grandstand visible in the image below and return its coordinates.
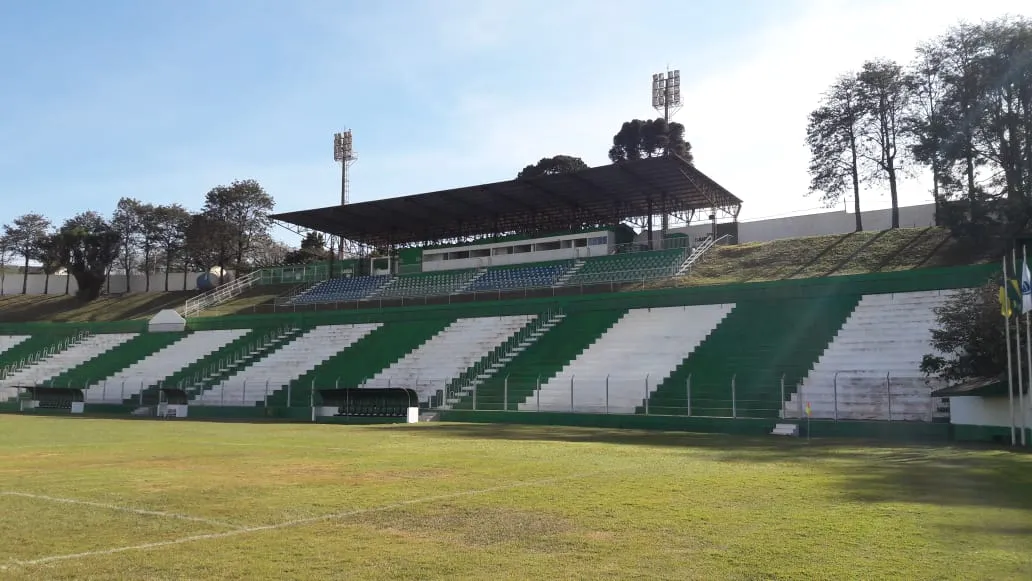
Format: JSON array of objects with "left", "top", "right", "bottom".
[{"left": 0, "top": 180, "right": 278, "bottom": 300}]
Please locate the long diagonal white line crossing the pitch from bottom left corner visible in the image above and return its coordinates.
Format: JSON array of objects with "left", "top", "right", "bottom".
[{"left": 12, "top": 469, "right": 623, "bottom": 569}]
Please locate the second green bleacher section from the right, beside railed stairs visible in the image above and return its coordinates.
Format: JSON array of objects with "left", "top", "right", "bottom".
[{"left": 453, "top": 309, "right": 626, "bottom": 410}]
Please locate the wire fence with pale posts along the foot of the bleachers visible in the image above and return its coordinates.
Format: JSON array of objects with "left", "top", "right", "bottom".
[{"left": 0, "top": 371, "right": 949, "bottom": 422}]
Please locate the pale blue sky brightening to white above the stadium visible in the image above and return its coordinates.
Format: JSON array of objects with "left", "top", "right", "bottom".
[{"left": 0, "top": 0, "right": 1024, "bottom": 241}]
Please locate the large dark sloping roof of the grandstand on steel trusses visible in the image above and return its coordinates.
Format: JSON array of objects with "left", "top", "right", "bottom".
[{"left": 272, "top": 156, "right": 742, "bottom": 246}]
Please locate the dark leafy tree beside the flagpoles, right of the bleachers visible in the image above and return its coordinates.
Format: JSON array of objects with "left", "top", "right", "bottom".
[{"left": 921, "top": 276, "right": 1025, "bottom": 382}]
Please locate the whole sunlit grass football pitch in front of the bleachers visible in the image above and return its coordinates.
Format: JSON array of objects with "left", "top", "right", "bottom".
[{"left": 0, "top": 416, "right": 1032, "bottom": 580}]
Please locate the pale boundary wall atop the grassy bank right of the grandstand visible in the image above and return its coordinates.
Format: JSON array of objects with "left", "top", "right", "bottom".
[{"left": 669, "top": 203, "right": 935, "bottom": 243}]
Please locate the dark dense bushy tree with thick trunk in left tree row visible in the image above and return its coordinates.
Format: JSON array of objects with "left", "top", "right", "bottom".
[{"left": 58, "top": 212, "right": 121, "bottom": 300}]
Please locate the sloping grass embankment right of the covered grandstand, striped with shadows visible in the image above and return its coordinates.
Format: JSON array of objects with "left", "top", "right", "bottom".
[{"left": 651, "top": 228, "right": 993, "bottom": 288}]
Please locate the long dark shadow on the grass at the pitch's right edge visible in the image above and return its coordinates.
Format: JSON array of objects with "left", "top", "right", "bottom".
[{"left": 414, "top": 423, "right": 1032, "bottom": 510}]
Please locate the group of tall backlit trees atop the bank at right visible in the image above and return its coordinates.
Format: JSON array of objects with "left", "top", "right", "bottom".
[{"left": 806, "top": 18, "right": 1032, "bottom": 238}]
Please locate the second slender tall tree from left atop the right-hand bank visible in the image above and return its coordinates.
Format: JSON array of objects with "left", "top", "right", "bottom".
[{"left": 857, "top": 60, "right": 910, "bottom": 228}]
